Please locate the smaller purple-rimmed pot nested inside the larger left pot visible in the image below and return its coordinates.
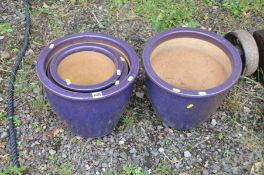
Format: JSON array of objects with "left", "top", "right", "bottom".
[{"left": 49, "top": 44, "right": 125, "bottom": 92}]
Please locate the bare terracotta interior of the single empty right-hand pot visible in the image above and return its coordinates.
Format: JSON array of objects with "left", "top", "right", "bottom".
[{"left": 151, "top": 38, "right": 232, "bottom": 90}]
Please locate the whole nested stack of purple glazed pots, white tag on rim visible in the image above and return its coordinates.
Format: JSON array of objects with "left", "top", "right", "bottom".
[{"left": 36, "top": 33, "right": 139, "bottom": 138}]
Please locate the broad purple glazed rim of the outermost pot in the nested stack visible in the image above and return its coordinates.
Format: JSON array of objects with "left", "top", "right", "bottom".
[{"left": 36, "top": 32, "right": 139, "bottom": 100}]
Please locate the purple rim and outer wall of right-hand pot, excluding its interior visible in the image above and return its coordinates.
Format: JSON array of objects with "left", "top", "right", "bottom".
[{"left": 143, "top": 28, "right": 242, "bottom": 130}]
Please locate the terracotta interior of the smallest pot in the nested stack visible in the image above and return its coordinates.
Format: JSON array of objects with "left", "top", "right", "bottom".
[{"left": 57, "top": 51, "right": 116, "bottom": 86}]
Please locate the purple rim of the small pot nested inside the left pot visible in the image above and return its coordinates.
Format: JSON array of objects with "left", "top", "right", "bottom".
[{"left": 48, "top": 43, "right": 126, "bottom": 92}]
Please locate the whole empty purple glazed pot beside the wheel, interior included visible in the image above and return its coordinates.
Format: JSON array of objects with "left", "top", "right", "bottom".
[{"left": 143, "top": 28, "right": 242, "bottom": 130}]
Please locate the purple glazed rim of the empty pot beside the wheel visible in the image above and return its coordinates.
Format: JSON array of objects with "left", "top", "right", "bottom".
[{"left": 143, "top": 28, "right": 242, "bottom": 98}]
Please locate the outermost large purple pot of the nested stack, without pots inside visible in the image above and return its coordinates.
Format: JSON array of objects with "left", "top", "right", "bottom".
[{"left": 36, "top": 33, "right": 139, "bottom": 138}]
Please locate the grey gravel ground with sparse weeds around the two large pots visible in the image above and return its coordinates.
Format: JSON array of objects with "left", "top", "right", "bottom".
[{"left": 0, "top": 0, "right": 264, "bottom": 175}]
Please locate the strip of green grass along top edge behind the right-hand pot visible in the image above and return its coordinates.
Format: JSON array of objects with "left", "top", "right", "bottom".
[{"left": 108, "top": 0, "right": 264, "bottom": 34}]
